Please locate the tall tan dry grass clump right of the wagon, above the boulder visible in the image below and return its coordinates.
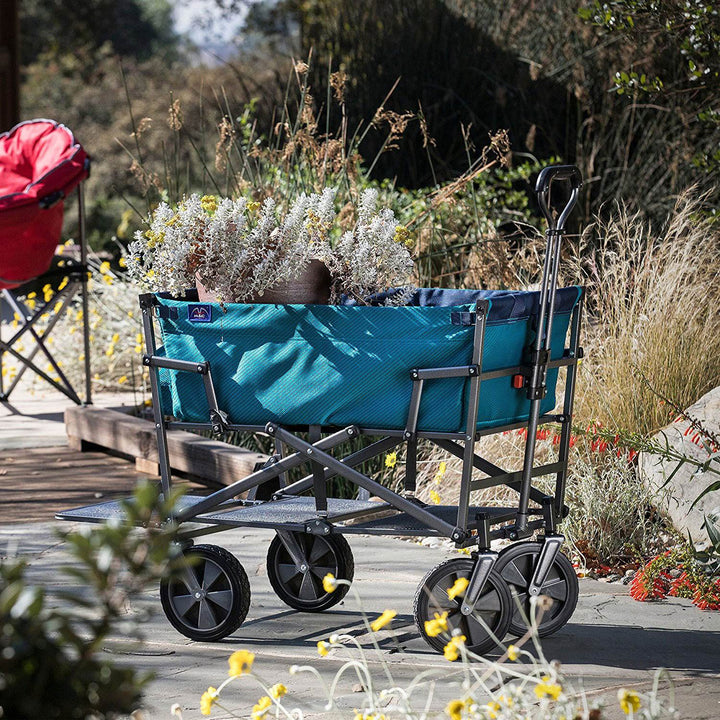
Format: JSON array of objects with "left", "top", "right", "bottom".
[{"left": 578, "top": 189, "right": 720, "bottom": 433}]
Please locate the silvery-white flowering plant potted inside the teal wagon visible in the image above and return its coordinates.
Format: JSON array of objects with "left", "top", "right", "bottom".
[{"left": 126, "top": 188, "right": 414, "bottom": 302}]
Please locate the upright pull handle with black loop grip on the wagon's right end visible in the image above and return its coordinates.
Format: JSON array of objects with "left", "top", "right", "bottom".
[{"left": 515, "top": 165, "right": 582, "bottom": 533}]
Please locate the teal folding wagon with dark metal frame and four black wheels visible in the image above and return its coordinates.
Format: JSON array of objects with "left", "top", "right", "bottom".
[{"left": 60, "top": 166, "right": 584, "bottom": 654}]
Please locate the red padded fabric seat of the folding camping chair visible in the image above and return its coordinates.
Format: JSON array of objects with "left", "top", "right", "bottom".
[{"left": 0, "top": 120, "right": 89, "bottom": 288}]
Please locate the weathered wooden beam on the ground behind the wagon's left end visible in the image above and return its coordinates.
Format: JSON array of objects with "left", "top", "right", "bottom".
[{"left": 65, "top": 406, "right": 267, "bottom": 485}]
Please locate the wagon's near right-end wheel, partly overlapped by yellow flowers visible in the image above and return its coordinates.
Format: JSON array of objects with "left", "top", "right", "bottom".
[{"left": 414, "top": 558, "right": 512, "bottom": 655}]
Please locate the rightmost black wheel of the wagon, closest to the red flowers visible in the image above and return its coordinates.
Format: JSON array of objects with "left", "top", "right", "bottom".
[{"left": 495, "top": 542, "right": 579, "bottom": 637}]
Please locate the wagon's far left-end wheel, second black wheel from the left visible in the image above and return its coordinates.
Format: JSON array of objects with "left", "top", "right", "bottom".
[{"left": 267, "top": 531, "right": 355, "bottom": 612}]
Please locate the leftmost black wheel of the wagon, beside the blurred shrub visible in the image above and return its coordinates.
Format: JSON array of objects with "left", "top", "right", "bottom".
[{"left": 160, "top": 545, "right": 250, "bottom": 642}]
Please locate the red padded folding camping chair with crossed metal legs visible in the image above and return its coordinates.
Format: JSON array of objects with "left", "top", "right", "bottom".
[{"left": 0, "top": 120, "right": 90, "bottom": 405}]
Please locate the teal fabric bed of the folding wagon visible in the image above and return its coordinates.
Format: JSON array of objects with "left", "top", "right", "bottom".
[{"left": 158, "top": 287, "right": 580, "bottom": 432}]
